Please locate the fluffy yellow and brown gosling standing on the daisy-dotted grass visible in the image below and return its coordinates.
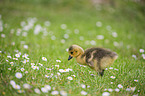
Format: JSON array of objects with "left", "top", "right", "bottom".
[{"left": 68, "top": 45, "right": 118, "bottom": 76}]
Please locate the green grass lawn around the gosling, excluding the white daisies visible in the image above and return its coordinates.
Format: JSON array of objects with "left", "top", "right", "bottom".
[{"left": 0, "top": 0, "right": 145, "bottom": 96}]
